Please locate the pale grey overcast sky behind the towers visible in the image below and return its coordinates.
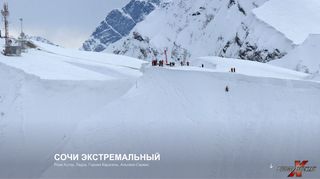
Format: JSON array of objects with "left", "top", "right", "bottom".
[{"left": 0, "top": 0, "right": 129, "bottom": 48}]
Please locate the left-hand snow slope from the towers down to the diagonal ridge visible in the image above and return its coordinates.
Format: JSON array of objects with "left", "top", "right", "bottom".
[{"left": 0, "top": 39, "right": 144, "bottom": 178}]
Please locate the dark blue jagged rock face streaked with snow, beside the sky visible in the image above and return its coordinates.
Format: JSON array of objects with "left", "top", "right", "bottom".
[{"left": 82, "top": 0, "right": 160, "bottom": 52}]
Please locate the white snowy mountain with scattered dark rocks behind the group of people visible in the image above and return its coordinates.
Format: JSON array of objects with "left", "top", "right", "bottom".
[{"left": 98, "top": 0, "right": 292, "bottom": 62}]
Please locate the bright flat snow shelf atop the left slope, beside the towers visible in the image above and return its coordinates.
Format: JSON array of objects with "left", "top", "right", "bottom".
[{"left": 1, "top": 41, "right": 144, "bottom": 80}]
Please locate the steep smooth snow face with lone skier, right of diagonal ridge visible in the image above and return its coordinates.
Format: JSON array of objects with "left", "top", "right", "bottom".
[{"left": 42, "top": 67, "right": 320, "bottom": 178}]
